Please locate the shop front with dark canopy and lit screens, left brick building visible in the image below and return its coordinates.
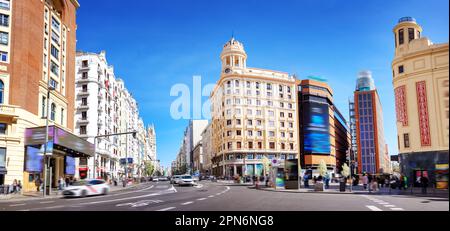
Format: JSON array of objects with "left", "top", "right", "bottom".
[{"left": 23, "top": 126, "right": 95, "bottom": 192}]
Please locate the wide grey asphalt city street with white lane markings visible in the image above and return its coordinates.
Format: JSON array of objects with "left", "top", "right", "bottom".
[{"left": 0, "top": 181, "right": 449, "bottom": 211}]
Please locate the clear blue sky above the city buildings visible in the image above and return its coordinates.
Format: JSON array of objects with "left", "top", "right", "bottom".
[{"left": 77, "top": 0, "right": 449, "bottom": 166}]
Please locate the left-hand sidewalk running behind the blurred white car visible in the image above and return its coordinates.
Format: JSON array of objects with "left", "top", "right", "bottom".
[{"left": 0, "top": 183, "right": 144, "bottom": 202}]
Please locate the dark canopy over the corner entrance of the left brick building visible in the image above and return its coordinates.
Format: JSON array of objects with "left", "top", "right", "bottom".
[{"left": 25, "top": 125, "right": 95, "bottom": 157}]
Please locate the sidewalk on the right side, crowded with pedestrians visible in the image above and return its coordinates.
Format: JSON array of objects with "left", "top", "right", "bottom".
[{"left": 255, "top": 183, "right": 449, "bottom": 198}]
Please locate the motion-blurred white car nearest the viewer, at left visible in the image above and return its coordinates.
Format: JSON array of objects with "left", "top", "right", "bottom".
[{"left": 63, "top": 180, "right": 109, "bottom": 197}]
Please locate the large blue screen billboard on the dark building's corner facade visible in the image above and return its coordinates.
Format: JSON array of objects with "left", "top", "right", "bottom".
[{"left": 302, "top": 102, "right": 331, "bottom": 154}]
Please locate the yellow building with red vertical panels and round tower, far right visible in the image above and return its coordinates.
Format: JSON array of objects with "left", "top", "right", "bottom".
[{"left": 392, "top": 17, "right": 449, "bottom": 184}]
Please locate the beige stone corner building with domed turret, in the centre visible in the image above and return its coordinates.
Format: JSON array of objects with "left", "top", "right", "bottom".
[{"left": 211, "top": 38, "right": 298, "bottom": 176}]
